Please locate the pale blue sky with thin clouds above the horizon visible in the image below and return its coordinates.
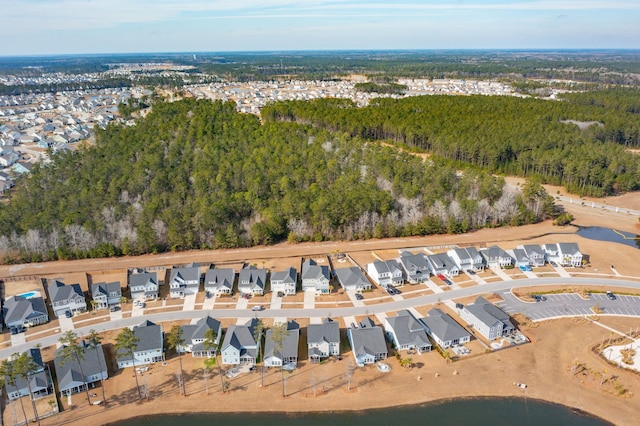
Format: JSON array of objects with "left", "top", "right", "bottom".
[{"left": 0, "top": 0, "right": 640, "bottom": 56}]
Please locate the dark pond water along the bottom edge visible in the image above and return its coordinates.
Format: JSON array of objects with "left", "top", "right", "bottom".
[{"left": 115, "top": 398, "right": 611, "bottom": 426}]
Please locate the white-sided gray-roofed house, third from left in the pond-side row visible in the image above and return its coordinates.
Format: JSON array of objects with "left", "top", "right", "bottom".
[{"left": 116, "top": 321, "right": 164, "bottom": 368}]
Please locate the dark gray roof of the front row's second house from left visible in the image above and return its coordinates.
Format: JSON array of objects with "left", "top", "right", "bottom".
[{"left": 53, "top": 341, "right": 107, "bottom": 391}]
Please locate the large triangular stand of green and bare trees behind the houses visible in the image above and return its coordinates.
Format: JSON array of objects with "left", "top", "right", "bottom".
[{"left": 0, "top": 99, "right": 553, "bottom": 262}]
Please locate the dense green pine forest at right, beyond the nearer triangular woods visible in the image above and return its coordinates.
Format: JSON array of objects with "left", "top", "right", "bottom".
[{"left": 262, "top": 95, "right": 640, "bottom": 196}]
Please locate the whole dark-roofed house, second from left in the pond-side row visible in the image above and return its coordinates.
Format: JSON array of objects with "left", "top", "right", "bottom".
[{"left": 53, "top": 340, "right": 109, "bottom": 396}]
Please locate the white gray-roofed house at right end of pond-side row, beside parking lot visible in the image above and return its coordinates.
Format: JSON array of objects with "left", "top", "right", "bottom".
[{"left": 460, "top": 296, "right": 515, "bottom": 340}]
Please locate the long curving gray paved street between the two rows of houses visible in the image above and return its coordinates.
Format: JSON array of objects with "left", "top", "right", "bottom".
[{"left": 5, "top": 277, "right": 640, "bottom": 359}]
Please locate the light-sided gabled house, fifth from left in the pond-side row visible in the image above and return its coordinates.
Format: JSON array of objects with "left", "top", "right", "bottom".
[{"left": 220, "top": 318, "right": 260, "bottom": 366}]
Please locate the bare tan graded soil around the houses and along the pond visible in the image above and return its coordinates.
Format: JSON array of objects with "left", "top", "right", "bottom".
[{"left": 0, "top": 187, "right": 640, "bottom": 425}]
